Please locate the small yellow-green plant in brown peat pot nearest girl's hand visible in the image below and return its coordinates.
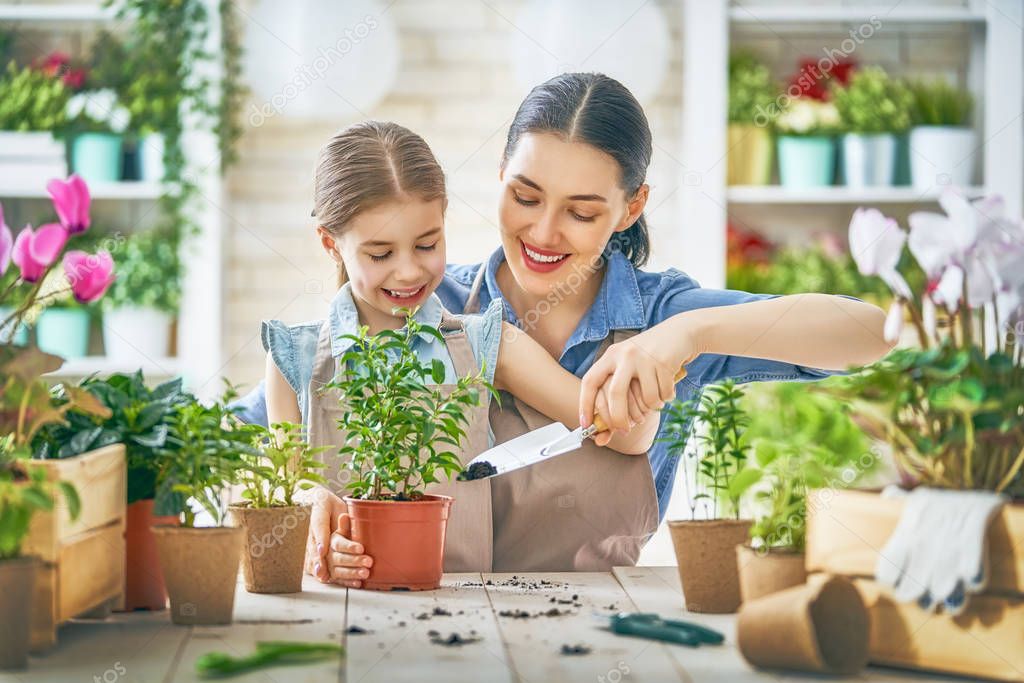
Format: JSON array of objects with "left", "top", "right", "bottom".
[{"left": 228, "top": 422, "right": 327, "bottom": 593}]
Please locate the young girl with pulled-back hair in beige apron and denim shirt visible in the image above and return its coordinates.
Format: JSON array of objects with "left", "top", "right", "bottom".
[{"left": 262, "top": 122, "right": 657, "bottom": 586}]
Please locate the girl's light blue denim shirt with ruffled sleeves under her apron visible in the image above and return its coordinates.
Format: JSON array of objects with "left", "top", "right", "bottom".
[{"left": 258, "top": 284, "right": 502, "bottom": 432}]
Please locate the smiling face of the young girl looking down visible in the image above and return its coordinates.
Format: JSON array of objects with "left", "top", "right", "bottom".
[{"left": 319, "top": 197, "right": 445, "bottom": 332}]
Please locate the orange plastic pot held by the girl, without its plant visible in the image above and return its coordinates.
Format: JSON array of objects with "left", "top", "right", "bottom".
[{"left": 345, "top": 496, "right": 454, "bottom": 591}]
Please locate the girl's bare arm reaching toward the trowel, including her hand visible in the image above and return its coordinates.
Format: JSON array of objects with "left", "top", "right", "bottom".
[{"left": 495, "top": 323, "right": 658, "bottom": 455}]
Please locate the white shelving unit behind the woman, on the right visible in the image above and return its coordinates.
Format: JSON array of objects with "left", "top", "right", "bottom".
[{"left": 670, "top": 0, "right": 1024, "bottom": 287}]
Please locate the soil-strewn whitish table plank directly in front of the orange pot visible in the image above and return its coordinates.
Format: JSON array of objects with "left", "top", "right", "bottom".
[{"left": 346, "top": 573, "right": 515, "bottom": 683}]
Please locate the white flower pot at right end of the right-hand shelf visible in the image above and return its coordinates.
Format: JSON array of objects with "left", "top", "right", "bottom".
[{"left": 910, "top": 126, "right": 977, "bottom": 189}]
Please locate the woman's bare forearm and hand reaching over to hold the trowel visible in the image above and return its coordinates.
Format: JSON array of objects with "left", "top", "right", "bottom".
[{"left": 580, "top": 294, "right": 893, "bottom": 428}]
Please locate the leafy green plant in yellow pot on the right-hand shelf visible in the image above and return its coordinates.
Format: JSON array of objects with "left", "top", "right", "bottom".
[{"left": 727, "top": 53, "right": 779, "bottom": 185}]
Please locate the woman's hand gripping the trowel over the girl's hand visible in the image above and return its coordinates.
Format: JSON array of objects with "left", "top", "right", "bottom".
[{"left": 580, "top": 324, "right": 699, "bottom": 431}]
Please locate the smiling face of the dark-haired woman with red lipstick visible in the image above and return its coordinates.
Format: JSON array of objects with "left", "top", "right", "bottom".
[{"left": 499, "top": 133, "right": 647, "bottom": 296}]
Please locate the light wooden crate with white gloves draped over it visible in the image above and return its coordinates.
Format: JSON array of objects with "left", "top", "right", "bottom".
[{"left": 807, "top": 489, "right": 1024, "bottom": 681}]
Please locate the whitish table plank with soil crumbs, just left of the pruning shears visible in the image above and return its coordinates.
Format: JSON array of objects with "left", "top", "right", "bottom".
[{"left": 483, "top": 572, "right": 685, "bottom": 683}]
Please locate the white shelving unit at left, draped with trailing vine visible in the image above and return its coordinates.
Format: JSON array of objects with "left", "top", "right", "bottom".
[{"left": 0, "top": 0, "right": 223, "bottom": 397}]
